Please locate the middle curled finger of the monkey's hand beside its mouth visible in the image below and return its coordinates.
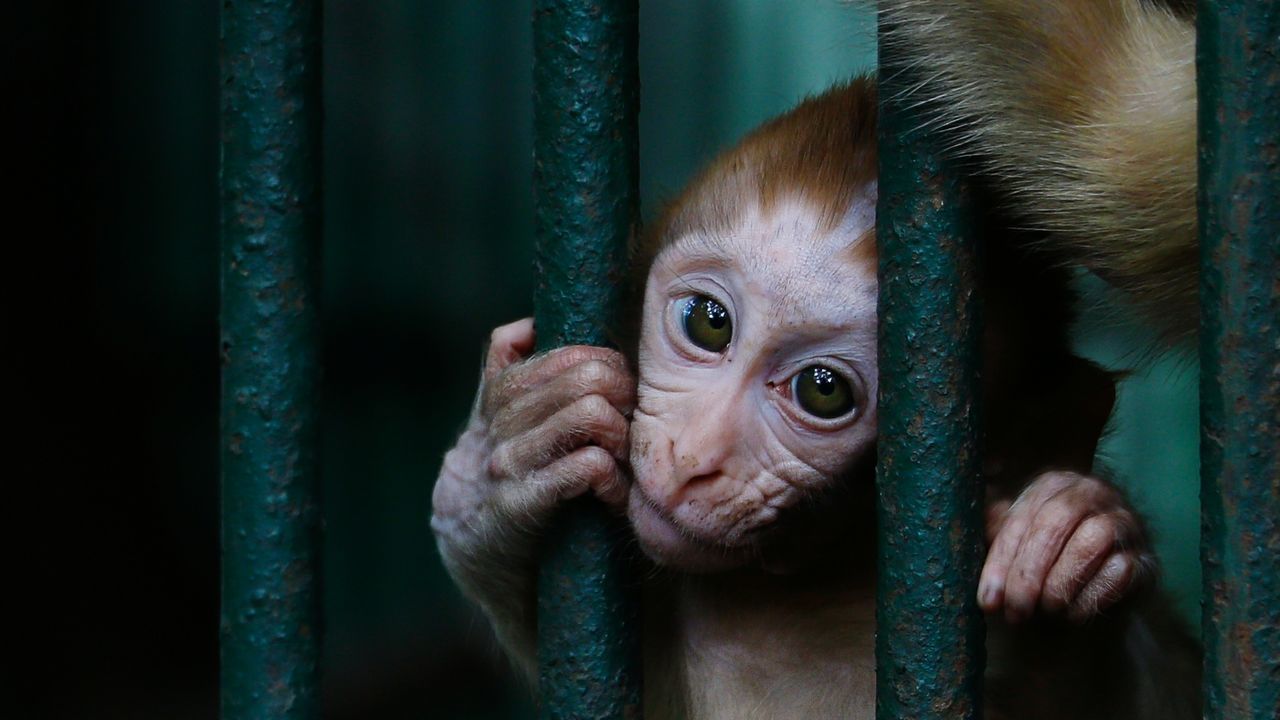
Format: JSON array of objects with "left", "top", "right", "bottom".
[{"left": 489, "top": 395, "right": 630, "bottom": 479}]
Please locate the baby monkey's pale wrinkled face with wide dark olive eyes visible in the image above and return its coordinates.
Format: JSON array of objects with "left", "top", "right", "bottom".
[{"left": 627, "top": 195, "right": 877, "bottom": 571}]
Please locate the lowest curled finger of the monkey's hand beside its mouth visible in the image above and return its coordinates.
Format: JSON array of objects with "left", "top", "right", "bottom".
[{"left": 504, "top": 446, "right": 628, "bottom": 519}]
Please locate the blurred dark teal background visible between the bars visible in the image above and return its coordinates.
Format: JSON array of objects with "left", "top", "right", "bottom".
[{"left": 0, "top": 0, "right": 1199, "bottom": 719}]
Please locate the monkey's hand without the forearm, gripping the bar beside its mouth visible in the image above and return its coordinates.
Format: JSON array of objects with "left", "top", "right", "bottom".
[{"left": 431, "top": 318, "right": 635, "bottom": 550}]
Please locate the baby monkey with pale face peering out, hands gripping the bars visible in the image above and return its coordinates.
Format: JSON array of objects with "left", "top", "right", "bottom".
[{"left": 431, "top": 79, "right": 1199, "bottom": 720}]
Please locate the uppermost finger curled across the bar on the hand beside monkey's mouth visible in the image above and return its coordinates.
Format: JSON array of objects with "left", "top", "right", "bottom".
[{"left": 490, "top": 360, "right": 636, "bottom": 442}]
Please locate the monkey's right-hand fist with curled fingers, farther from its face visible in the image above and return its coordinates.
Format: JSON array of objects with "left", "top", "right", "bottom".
[{"left": 978, "top": 471, "right": 1157, "bottom": 623}]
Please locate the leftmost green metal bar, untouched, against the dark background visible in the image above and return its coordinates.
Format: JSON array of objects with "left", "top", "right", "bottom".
[{"left": 220, "top": 0, "right": 321, "bottom": 720}]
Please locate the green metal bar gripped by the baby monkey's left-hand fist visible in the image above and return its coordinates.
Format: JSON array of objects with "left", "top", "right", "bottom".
[{"left": 534, "top": 0, "right": 640, "bottom": 720}]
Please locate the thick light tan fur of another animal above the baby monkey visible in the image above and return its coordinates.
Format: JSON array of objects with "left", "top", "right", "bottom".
[{"left": 881, "top": 0, "right": 1198, "bottom": 337}]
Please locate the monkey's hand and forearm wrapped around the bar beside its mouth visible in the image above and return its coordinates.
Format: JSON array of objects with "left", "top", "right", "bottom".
[{"left": 431, "top": 318, "right": 636, "bottom": 670}]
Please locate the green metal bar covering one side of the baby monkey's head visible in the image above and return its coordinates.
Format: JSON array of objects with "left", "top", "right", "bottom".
[{"left": 876, "top": 12, "right": 986, "bottom": 720}]
